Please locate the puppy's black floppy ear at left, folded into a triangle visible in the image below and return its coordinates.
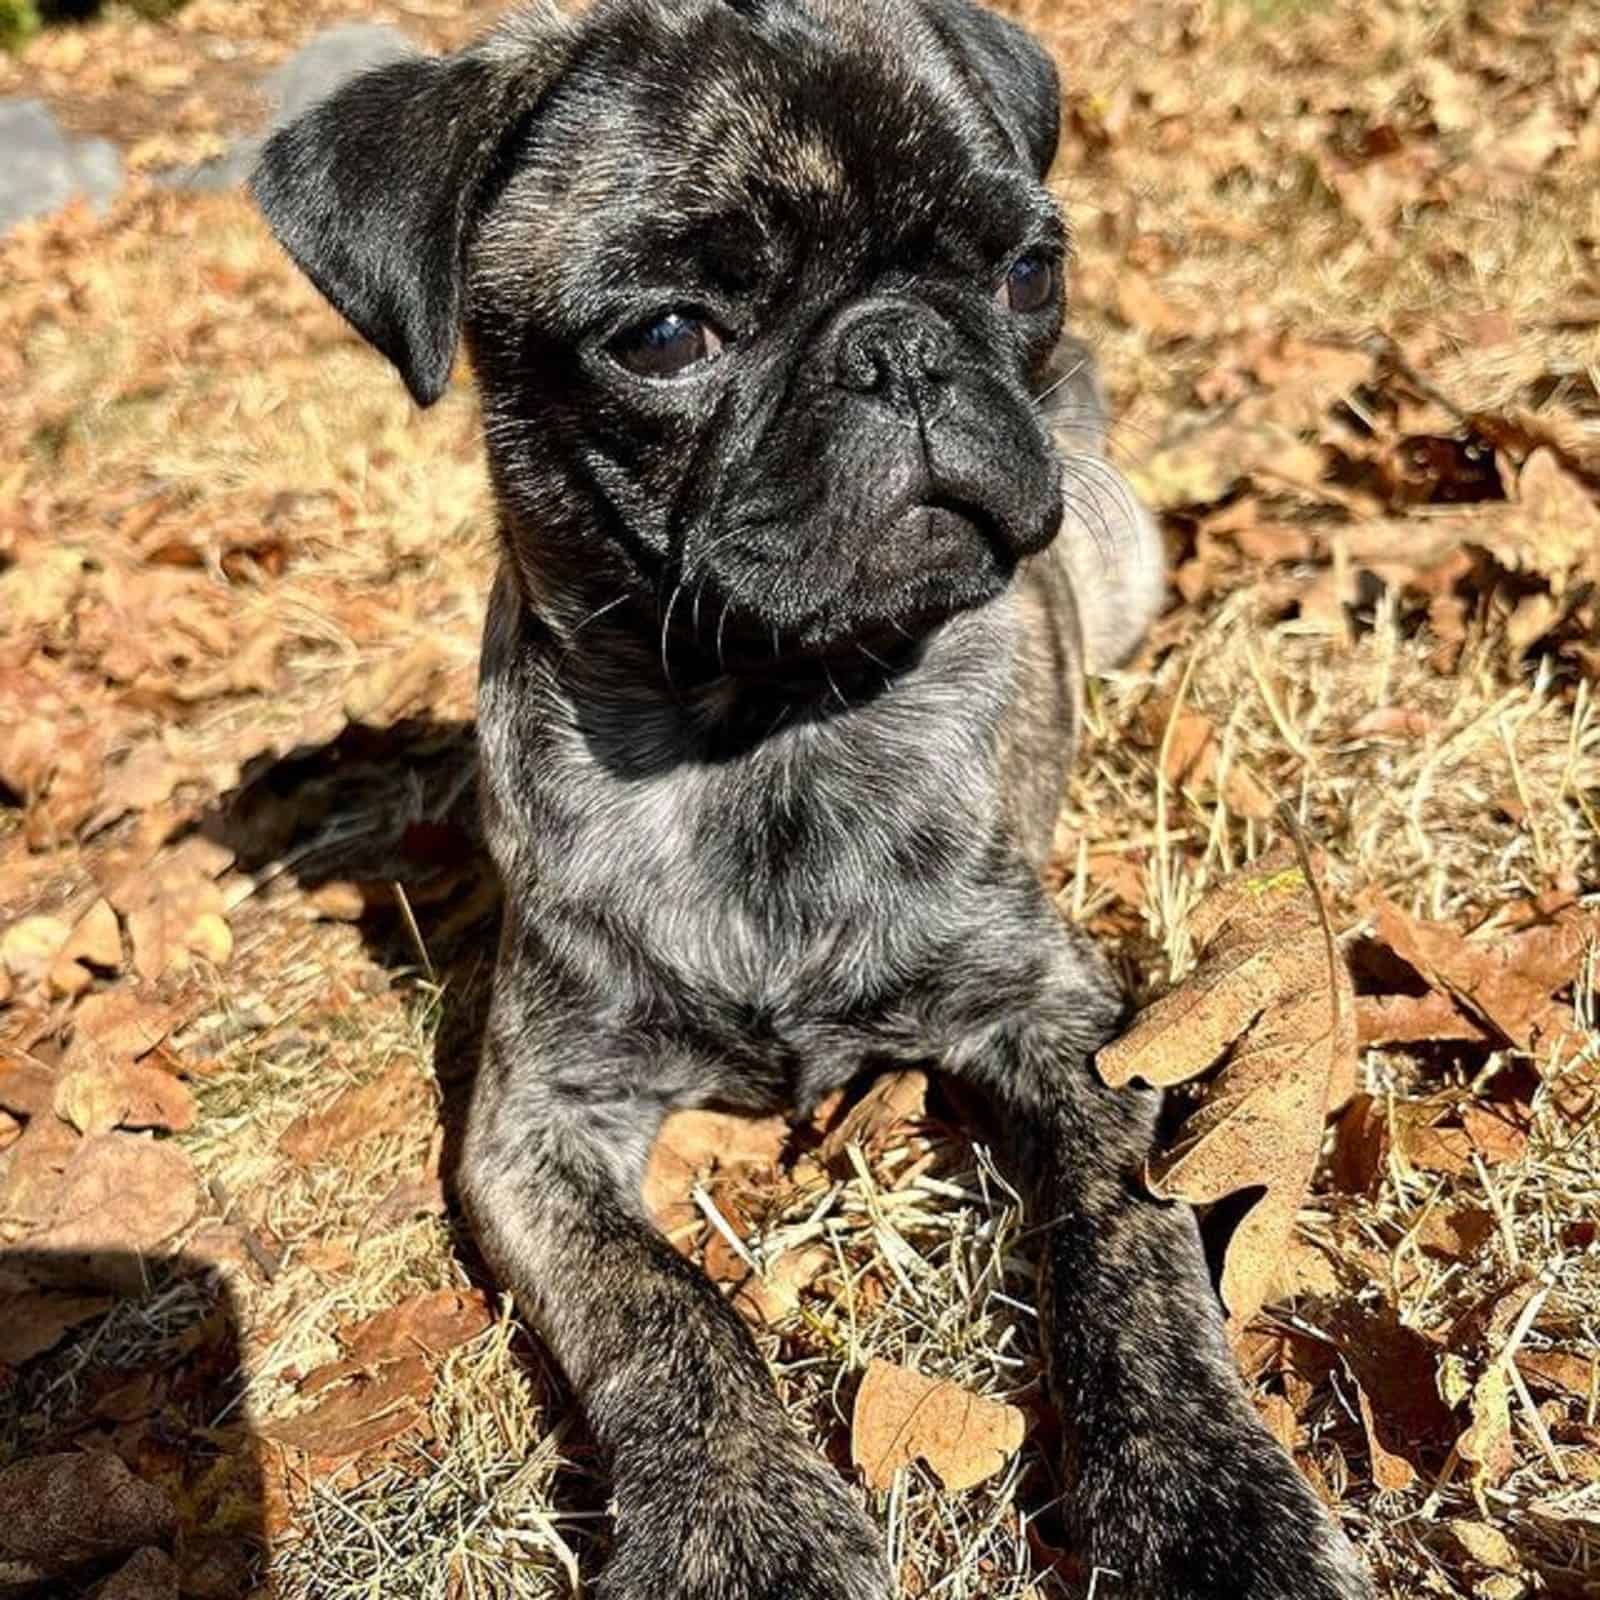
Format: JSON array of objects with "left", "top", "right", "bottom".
[{"left": 250, "top": 13, "right": 558, "bottom": 405}]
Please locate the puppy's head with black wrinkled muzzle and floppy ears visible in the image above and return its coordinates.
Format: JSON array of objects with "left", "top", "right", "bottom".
[{"left": 253, "top": 0, "right": 1100, "bottom": 653}]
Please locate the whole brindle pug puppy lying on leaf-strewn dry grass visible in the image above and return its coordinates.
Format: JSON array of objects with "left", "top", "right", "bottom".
[{"left": 254, "top": 0, "right": 1370, "bottom": 1600}]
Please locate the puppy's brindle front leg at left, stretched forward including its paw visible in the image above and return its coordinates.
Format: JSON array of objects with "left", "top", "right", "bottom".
[{"left": 461, "top": 960, "right": 890, "bottom": 1600}]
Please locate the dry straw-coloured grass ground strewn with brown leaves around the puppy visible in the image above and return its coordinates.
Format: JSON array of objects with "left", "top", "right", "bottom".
[{"left": 0, "top": 0, "right": 1600, "bottom": 1600}]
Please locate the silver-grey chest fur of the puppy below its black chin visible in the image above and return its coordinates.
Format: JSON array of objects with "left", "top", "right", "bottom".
[{"left": 480, "top": 566, "right": 1049, "bottom": 1104}]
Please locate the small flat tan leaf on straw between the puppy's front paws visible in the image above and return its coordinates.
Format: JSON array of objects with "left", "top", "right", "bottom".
[{"left": 850, "top": 1360, "right": 1026, "bottom": 1491}]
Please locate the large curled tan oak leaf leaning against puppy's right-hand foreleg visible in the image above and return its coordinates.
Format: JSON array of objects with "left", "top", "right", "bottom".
[{"left": 1098, "top": 861, "right": 1355, "bottom": 1331}]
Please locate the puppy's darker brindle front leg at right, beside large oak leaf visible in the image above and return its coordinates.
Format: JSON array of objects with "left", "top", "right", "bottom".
[{"left": 949, "top": 928, "right": 1371, "bottom": 1600}]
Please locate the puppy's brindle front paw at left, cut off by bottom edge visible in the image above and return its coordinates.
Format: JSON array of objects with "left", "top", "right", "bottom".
[{"left": 595, "top": 1440, "right": 891, "bottom": 1600}]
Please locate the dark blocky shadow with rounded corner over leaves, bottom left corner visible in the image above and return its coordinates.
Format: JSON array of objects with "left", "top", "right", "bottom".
[{"left": 0, "top": 1250, "right": 267, "bottom": 1600}]
